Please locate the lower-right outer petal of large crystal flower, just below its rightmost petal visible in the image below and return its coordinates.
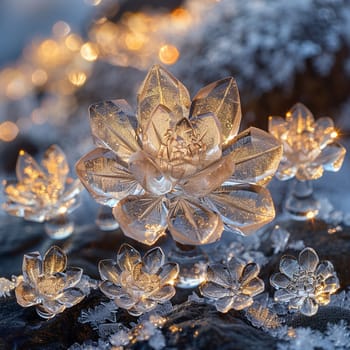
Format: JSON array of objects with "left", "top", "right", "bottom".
[{"left": 207, "top": 184, "right": 275, "bottom": 234}]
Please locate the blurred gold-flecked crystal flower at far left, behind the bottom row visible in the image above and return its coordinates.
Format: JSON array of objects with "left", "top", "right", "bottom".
[{"left": 3, "top": 145, "right": 81, "bottom": 222}]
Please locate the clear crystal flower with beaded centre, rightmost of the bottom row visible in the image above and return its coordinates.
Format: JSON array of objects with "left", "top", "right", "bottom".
[{"left": 270, "top": 247, "right": 339, "bottom": 316}]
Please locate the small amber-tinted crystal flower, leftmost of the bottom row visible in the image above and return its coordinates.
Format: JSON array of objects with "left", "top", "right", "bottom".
[{"left": 15, "top": 246, "right": 85, "bottom": 319}]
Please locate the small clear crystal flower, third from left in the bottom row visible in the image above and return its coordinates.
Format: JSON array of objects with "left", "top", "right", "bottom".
[{"left": 199, "top": 258, "right": 265, "bottom": 312}]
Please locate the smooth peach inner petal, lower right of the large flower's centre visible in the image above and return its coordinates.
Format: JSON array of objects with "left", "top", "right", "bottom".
[{"left": 180, "top": 154, "right": 235, "bottom": 197}]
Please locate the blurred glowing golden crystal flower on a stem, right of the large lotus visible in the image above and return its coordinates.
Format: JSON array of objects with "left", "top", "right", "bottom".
[{"left": 269, "top": 103, "right": 346, "bottom": 181}]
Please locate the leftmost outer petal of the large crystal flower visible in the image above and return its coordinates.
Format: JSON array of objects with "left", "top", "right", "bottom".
[{"left": 76, "top": 148, "right": 142, "bottom": 206}]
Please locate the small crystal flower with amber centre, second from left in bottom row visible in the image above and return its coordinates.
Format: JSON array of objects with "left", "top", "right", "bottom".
[{"left": 98, "top": 244, "right": 179, "bottom": 316}]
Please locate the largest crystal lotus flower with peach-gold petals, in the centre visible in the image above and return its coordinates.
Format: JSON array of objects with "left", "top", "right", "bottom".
[{"left": 76, "top": 66, "right": 282, "bottom": 245}]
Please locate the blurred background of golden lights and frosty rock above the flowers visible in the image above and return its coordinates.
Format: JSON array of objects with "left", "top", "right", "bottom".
[{"left": 0, "top": 0, "right": 350, "bottom": 177}]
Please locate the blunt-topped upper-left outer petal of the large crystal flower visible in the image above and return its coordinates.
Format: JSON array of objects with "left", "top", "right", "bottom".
[{"left": 89, "top": 100, "right": 140, "bottom": 162}]
